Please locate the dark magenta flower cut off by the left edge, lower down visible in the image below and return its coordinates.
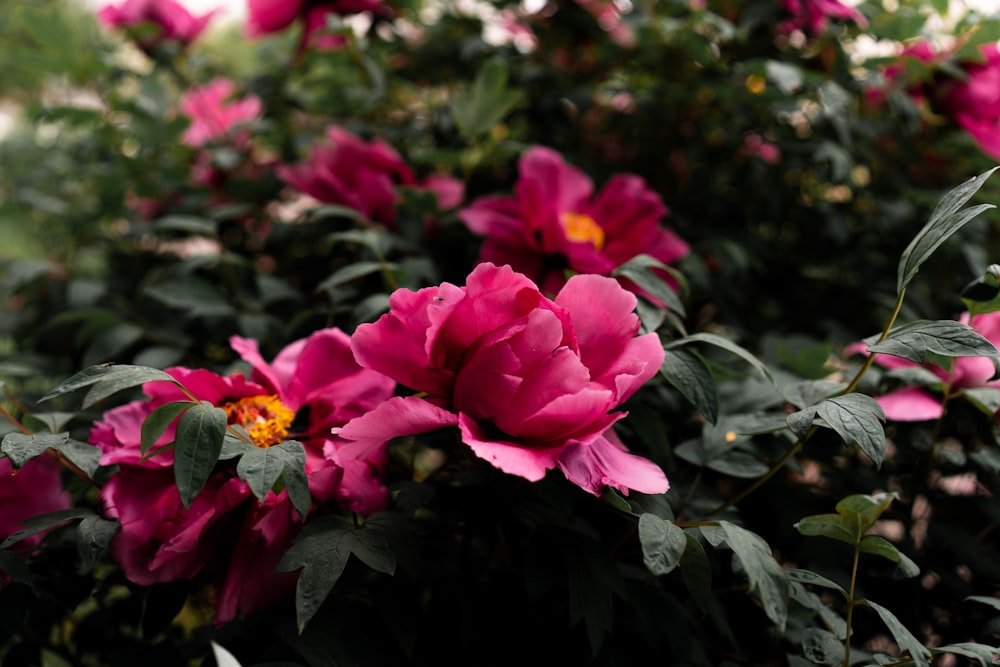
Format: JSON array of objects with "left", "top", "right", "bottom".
[{"left": 0, "top": 455, "right": 71, "bottom": 548}]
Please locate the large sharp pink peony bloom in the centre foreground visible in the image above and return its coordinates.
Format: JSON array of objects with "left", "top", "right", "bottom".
[{"left": 336, "top": 264, "right": 669, "bottom": 495}]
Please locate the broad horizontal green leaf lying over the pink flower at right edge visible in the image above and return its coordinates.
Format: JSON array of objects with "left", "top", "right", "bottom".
[{"left": 868, "top": 320, "right": 1000, "bottom": 364}]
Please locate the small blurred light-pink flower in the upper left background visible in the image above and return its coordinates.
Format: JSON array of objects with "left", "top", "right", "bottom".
[{"left": 180, "top": 79, "right": 263, "bottom": 148}]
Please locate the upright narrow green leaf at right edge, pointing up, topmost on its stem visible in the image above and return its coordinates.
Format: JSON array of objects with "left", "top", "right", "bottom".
[{"left": 896, "top": 167, "right": 1000, "bottom": 293}]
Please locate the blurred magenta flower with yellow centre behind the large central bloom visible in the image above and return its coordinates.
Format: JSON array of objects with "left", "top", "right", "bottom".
[{"left": 458, "top": 146, "right": 688, "bottom": 294}]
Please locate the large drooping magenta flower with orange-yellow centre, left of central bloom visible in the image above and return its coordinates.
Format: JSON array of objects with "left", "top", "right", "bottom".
[{"left": 90, "top": 329, "right": 395, "bottom": 623}]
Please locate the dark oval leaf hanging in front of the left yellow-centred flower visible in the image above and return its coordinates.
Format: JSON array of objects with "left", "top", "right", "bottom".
[{"left": 174, "top": 403, "right": 226, "bottom": 507}]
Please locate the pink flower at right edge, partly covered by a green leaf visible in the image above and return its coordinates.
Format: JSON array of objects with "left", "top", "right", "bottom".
[{"left": 846, "top": 312, "right": 1000, "bottom": 421}]
